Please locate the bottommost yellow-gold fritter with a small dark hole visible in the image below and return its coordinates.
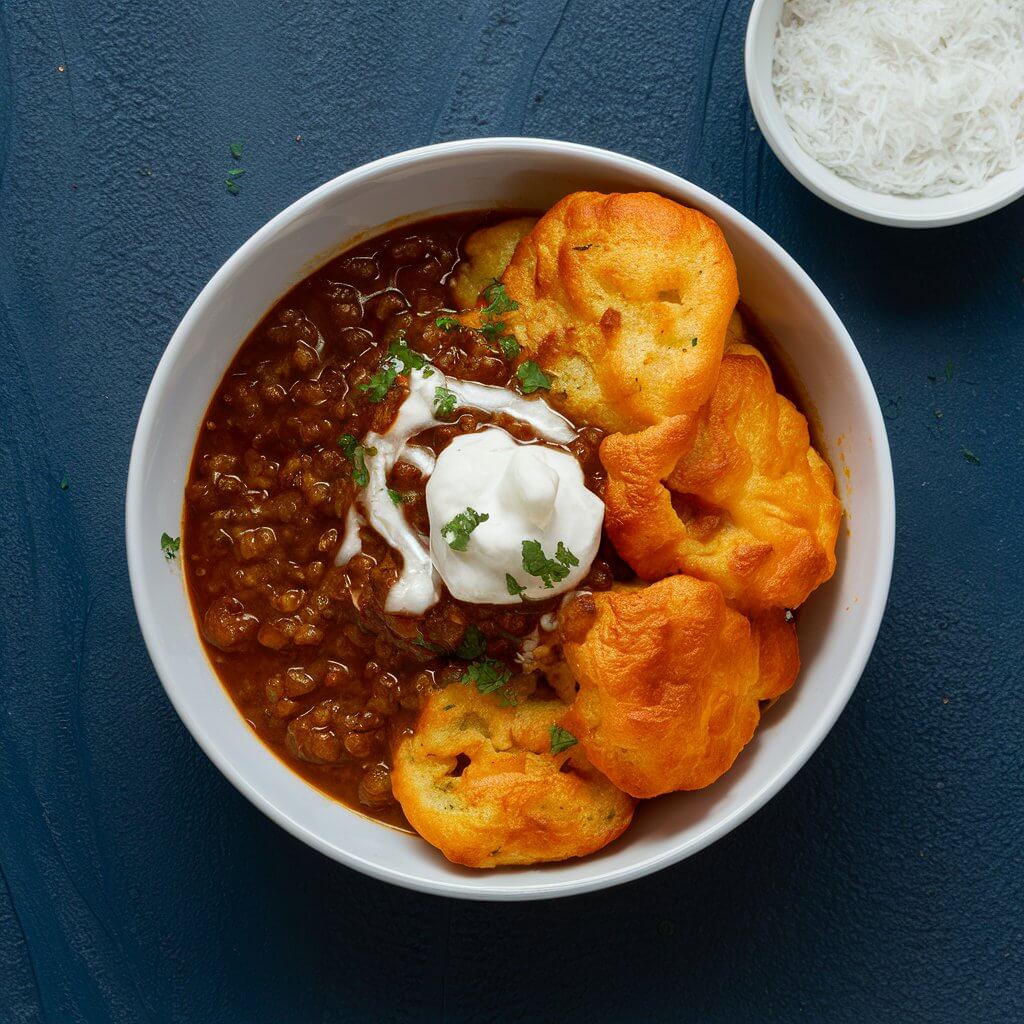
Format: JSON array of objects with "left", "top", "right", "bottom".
[{"left": 391, "top": 683, "right": 634, "bottom": 867}]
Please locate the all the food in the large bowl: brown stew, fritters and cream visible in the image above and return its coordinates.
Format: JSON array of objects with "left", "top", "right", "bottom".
[{"left": 183, "top": 193, "right": 840, "bottom": 867}]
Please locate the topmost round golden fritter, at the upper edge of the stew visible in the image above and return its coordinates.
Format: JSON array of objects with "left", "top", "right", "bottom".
[{"left": 502, "top": 193, "right": 738, "bottom": 431}]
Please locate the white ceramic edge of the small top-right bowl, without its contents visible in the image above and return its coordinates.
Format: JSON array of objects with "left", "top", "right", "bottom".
[{"left": 743, "top": 0, "right": 1024, "bottom": 227}]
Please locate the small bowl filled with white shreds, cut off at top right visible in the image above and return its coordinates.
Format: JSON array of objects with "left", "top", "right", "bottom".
[{"left": 744, "top": 0, "right": 1024, "bottom": 227}]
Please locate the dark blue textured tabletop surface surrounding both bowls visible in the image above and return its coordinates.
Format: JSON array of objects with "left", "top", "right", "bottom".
[{"left": 0, "top": 0, "right": 1024, "bottom": 1024}]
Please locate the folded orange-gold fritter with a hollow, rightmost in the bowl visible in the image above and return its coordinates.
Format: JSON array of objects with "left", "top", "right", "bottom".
[{"left": 601, "top": 343, "right": 841, "bottom": 612}]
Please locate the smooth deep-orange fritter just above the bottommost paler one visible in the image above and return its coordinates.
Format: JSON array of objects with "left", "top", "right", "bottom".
[{"left": 562, "top": 575, "right": 800, "bottom": 798}]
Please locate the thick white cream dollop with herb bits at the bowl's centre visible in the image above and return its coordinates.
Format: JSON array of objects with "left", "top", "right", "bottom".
[{"left": 426, "top": 427, "right": 604, "bottom": 604}]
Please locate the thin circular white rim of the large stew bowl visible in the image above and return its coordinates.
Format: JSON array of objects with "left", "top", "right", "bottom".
[{"left": 125, "top": 136, "right": 896, "bottom": 901}]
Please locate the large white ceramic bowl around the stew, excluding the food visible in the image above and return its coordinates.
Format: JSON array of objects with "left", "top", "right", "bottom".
[{"left": 126, "top": 138, "right": 895, "bottom": 899}]
